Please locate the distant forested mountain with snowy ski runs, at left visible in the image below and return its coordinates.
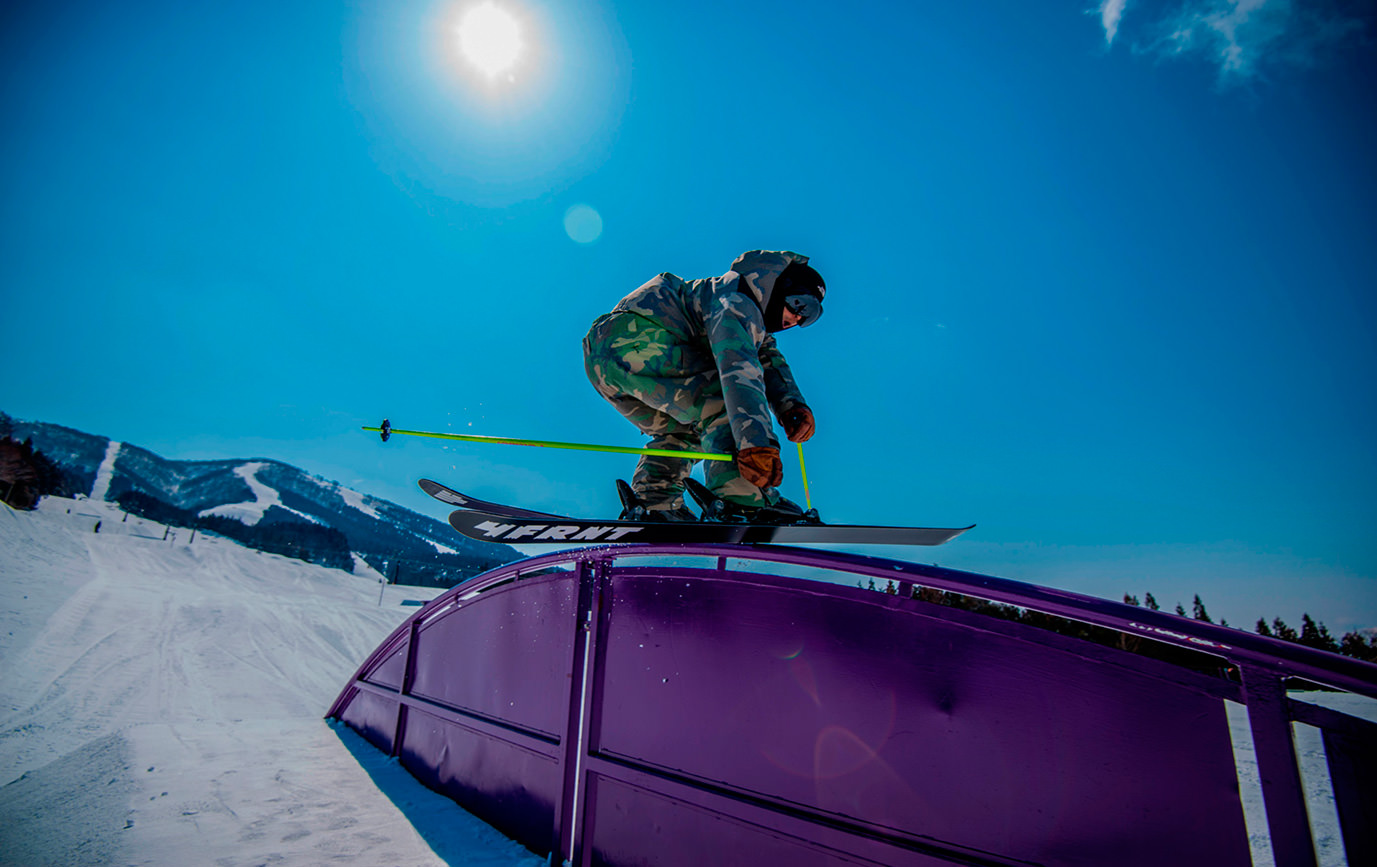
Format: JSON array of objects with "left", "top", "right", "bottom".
[{"left": 12, "top": 420, "right": 522, "bottom": 586}]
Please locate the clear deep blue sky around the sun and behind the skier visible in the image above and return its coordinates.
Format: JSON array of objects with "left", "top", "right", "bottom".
[{"left": 0, "top": 0, "right": 1377, "bottom": 632}]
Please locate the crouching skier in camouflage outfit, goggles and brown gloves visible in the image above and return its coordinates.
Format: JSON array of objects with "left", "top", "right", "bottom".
[{"left": 584, "top": 250, "right": 826, "bottom": 523}]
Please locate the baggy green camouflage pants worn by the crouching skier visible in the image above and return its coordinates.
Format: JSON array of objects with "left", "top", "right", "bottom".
[{"left": 584, "top": 312, "right": 779, "bottom": 509}]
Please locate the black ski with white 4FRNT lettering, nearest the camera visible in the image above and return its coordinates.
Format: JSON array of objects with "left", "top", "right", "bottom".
[{"left": 449, "top": 508, "right": 975, "bottom": 545}]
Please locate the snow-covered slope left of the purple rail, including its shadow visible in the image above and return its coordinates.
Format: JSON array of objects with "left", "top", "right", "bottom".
[{"left": 0, "top": 498, "right": 544, "bottom": 867}]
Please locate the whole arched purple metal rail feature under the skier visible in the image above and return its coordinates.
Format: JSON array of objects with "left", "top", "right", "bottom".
[{"left": 329, "top": 546, "right": 1377, "bottom": 867}]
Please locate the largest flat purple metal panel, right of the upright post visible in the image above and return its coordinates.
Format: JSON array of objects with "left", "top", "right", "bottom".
[{"left": 592, "top": 571, "right": 1250, "bottom": 867}]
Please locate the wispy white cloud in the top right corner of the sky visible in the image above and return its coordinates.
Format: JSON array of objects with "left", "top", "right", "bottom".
[{"left": 1099, "top": 0, "right": 1371, "bottom": 85}]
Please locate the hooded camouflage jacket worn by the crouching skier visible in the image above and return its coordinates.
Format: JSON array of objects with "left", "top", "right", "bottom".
[{"left": 613, "top": 250, "right": 808, "bottom": 449}]
